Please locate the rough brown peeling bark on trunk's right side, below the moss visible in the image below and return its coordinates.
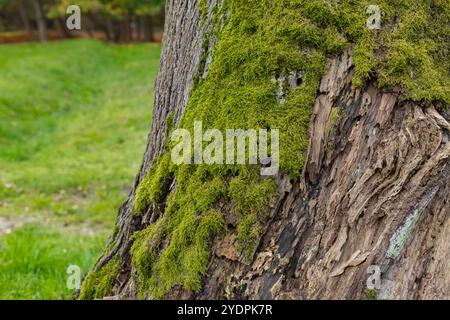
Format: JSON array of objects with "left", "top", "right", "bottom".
[{"left": 203, "top": 52, "right": 450, "bottom": 299}]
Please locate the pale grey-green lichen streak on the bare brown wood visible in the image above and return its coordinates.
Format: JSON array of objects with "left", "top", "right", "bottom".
[{"left": 386, "top": 187, "right": 439, "bottom": 259}]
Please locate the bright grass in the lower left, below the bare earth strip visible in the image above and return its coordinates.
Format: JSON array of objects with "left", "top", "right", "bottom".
[{"left": 0, "top": 225, "right": 104, "bottom": 299}]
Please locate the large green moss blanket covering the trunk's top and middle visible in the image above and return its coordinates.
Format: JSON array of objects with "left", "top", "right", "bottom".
[{"left": 128, "top": 0, "right": 450, "bottom": 298}]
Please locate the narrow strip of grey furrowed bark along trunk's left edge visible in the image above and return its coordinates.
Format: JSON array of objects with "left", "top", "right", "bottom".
[{"left": 95, "top": 0, "right": 209, "bottom": 297}]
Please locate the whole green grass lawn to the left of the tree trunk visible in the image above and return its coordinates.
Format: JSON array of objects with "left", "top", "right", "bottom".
[{"left": 0, "top": 40, "right": 160, "bottom": 299}]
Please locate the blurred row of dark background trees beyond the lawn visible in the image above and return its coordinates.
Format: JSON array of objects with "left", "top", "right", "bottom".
[{"left": 0, "top": 0, "right": 165, "bottom": 43}]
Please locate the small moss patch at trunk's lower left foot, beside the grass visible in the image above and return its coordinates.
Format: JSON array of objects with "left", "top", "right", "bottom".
[{"left": 78, "top": 256, "right": 120, "bottom": 300}]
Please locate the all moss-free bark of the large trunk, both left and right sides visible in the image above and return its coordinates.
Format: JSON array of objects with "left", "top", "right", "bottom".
[{"left": 81, "top": 0, "right": 450, "bottom": 299}]
